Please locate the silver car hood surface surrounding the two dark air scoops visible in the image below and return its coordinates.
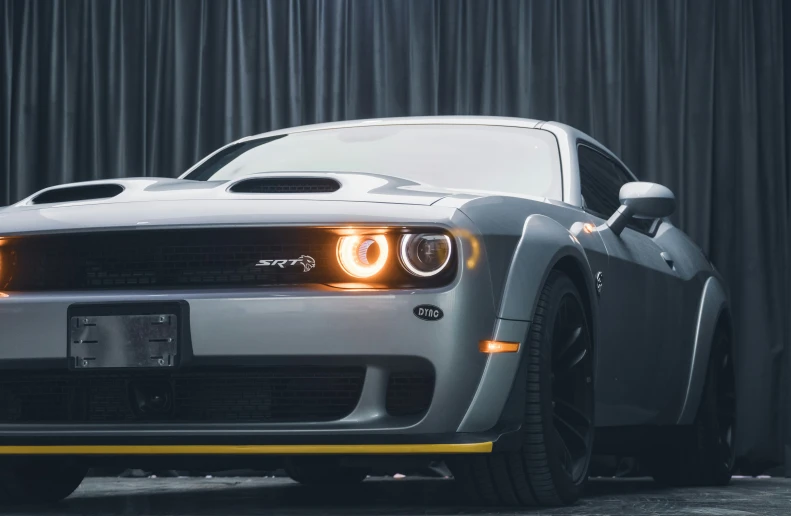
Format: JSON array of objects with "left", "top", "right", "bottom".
[{"left": 0, "top": 173, "right": 486, "bottom": 236}]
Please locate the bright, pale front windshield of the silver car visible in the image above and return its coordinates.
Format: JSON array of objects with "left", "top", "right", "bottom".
[{"left": 185, "top": 124, "right": 562, "bottom": 200}]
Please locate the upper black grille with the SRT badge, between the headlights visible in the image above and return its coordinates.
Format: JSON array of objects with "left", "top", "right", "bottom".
[{"left": 5, "top": 228, "right": 339, "bottom": 291}]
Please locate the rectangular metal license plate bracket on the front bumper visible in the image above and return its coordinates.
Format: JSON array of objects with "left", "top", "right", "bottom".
[{"left": 68, "top": 310, "right": 180, "bottom": 369}]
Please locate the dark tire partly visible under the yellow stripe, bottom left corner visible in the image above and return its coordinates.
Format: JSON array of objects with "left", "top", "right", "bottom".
[{"left": 0, "top": 458, "right": 88, "bottom": 503}]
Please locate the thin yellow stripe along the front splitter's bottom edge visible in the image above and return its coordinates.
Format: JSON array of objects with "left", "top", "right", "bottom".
[{"left": 0, "top": 442, "right": 492, "bottom": 455}]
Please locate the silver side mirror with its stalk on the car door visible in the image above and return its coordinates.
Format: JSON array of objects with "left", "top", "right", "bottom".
[{"left": 607, "top": 182, "right": 676, "bottom": 235}]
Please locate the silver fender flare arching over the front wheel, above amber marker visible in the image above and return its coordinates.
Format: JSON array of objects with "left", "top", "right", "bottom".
[{"left": 497, "top": 215, "right": 598, "bottom": 326}]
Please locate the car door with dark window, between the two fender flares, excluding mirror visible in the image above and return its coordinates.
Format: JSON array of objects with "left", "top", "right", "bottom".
[{"left": 577, "top": 144, "right": 686, "bottom": 426}]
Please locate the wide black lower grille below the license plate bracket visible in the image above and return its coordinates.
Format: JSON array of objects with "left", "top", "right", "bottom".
[{"left": 0, "top": 367, "right": 365, "bottom": 423}]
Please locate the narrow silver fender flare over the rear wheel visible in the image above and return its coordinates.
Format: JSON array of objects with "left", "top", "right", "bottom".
[{"left": 677, "top": 276, "right": 736, "bottom": 425}]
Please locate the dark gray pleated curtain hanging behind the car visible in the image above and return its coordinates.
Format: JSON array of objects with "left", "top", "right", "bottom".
[{"left": 0, "top": 0, "right": 791, "bottom": 468}]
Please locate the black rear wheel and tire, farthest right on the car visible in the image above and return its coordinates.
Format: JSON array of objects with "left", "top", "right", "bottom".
[{"left": 645, "top": 326, "right": 736, "bottom": 487}]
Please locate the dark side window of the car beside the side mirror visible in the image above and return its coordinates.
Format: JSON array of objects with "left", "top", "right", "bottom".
[{"left": 577, "top": 145, "right": 654, "bottom": 233}]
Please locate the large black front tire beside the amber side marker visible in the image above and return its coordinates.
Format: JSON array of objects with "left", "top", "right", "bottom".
[{"left": 450, "top": 271, "right": 594, "bottom": 506}]
